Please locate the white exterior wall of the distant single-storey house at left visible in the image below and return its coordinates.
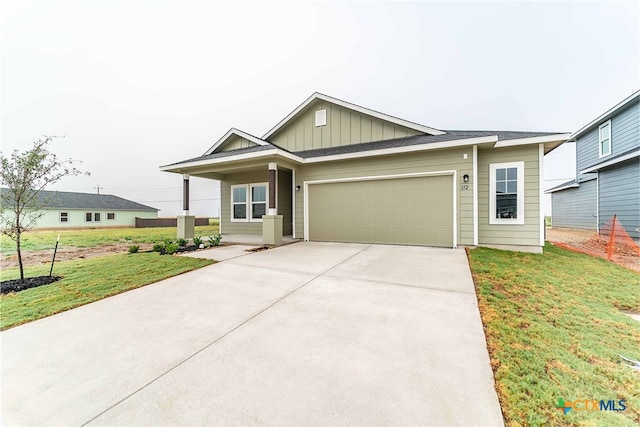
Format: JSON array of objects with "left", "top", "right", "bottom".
[{"left": 35, "top": 208, "right": 158, "bottom": 228}]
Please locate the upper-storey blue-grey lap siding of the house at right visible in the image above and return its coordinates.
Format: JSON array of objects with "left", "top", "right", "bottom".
[{"left": 576, "top": 99, "right": 640, "bottom": 180}]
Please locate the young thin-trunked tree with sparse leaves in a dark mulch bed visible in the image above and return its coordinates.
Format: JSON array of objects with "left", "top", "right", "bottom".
[{"left": 0, "top": 136, "right": 89, "bottom": 282}]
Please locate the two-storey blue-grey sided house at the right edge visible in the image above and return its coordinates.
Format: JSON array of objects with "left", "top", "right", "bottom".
[{"left": 546, "top": 91, "right": 640, "bottom": 239}]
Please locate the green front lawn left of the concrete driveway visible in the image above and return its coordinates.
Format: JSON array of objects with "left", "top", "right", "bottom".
[{"left": 0, "top": 252, "right": 214, "bottom": 330}]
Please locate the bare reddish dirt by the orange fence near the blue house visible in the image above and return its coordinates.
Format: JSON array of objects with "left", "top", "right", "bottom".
[{"left": 547, "top": 228, "right": 640, "bottom": 271}]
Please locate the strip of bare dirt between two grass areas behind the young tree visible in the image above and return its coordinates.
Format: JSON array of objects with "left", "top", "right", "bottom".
[{"left": 0, "top": 243, "right": 153, "bottom": 269}]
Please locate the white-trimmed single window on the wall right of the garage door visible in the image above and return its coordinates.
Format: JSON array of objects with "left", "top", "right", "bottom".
[{"left": 489, "top": 162, "right": 524, "bottom": 224}]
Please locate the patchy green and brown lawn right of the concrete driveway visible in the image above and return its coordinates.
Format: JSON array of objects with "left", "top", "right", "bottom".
[{"left": 469, "top": 244, "right": 640, "bottom": 426}]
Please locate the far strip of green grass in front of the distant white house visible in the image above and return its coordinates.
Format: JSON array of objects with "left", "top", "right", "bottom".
[{"left": 0, "top": 219, "right": 219, "bottom": 253}]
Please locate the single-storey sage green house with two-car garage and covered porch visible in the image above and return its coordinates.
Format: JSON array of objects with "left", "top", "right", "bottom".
[{"left": 161, "top": 93, "right": 569, "bottom": 252}]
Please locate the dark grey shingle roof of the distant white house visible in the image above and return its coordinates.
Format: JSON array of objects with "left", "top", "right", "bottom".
[{"left": 0, "top": 188, "right": 159, "bottom": 211}]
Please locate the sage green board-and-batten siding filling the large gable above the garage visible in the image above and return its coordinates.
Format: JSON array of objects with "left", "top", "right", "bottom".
[{"left": 269, "top": 101, "right": 422, "bottom": 152}]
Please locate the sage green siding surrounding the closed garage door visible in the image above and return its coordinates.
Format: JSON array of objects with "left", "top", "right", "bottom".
[{"left": 295, "top": 147, "right": 474, "bottom": 245}]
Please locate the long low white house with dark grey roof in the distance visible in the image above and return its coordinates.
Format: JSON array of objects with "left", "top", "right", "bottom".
[{"left": 2, "top": 188, "right": 158, "bottom": 228}]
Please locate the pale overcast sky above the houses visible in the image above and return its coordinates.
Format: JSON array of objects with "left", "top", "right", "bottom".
[{"left": 0, "top": 0, "right": 640, "bottom": 216}]
